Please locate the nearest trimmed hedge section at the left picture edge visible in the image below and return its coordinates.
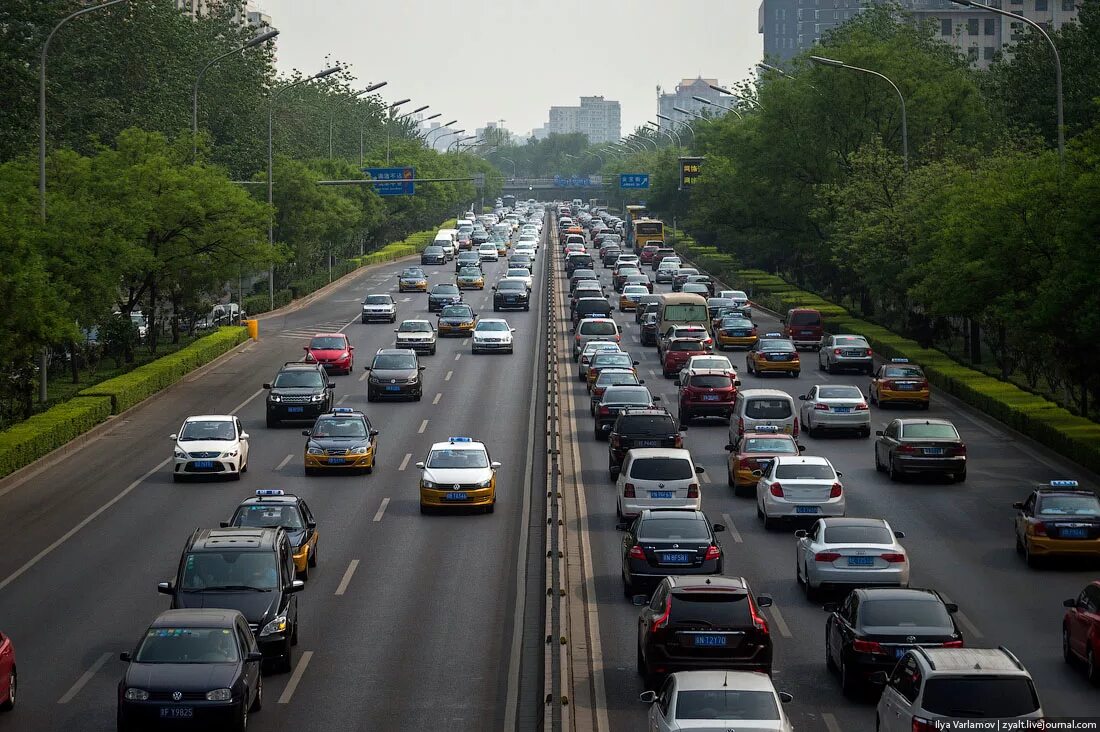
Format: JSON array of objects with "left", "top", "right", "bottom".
[{"left": 0, "top": 396, "right": 111, "bottom": 478}]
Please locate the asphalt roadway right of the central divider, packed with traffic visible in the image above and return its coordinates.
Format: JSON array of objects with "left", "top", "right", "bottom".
[{"left": 550, "top": 214, "right": 1100, "bottom": 732}]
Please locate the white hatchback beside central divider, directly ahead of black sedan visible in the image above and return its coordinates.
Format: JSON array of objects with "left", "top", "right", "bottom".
[{"left": 615, "top": 447, "right": 704, "bottom": 520}]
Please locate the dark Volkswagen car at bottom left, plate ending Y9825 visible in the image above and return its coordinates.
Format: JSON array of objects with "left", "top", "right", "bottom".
[{"left": 118, "top": 609, "right": 264, "bottom": 732}]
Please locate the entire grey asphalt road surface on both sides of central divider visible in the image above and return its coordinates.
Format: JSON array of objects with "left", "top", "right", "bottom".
[{"left": 0, "top": 205, "right": 1100, "bottom": 732}]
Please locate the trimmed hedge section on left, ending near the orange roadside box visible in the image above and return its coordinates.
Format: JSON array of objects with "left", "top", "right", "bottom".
[{"left": 79, "top": 326, "right": 249, "bottom": 414}]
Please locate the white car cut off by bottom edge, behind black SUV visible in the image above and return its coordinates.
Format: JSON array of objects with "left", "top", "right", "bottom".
[{"left": 638, "top": 670, "right": 794, "bottom": 732}]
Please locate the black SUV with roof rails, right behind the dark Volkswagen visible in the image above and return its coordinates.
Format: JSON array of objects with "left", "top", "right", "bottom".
[{"left": 156, "top": 527, "right": 306, "bottom": 671}]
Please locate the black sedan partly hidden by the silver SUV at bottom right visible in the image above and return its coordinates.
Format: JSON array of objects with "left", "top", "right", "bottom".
[{"left": 823, "top": 588, "right": 963, "bottom": 696}]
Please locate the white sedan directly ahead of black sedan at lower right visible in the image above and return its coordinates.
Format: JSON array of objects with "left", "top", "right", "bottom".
[{"left": 794, "top": 518, "right": 909, "bottom": 600}]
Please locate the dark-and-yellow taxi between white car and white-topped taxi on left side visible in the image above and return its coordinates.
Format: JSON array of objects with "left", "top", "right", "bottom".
[{"left": 301, "top": 406, "right": 378, "bottom": 476}]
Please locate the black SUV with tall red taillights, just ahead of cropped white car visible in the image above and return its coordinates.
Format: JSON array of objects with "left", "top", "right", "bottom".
[{"left": 638, "top": 577, "right": 772, "bottom": 689}]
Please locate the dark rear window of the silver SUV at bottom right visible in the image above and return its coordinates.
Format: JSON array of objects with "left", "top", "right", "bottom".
[{"left": 923, "top": 676, "right": 1038, "bottom": 719}]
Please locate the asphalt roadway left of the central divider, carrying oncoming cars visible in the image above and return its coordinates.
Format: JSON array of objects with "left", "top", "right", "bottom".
[{"left": 0, "top": 225, "right": 546, "bottom": 731}]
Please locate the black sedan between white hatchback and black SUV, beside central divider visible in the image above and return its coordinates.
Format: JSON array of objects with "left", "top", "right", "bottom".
[{"left": 623, "top": 510, "right": 726, "bottom": 598}]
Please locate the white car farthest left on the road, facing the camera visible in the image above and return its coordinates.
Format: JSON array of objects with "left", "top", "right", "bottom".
[{"left": 172, "top": 414, "right": 249, "bottom": 482}]
